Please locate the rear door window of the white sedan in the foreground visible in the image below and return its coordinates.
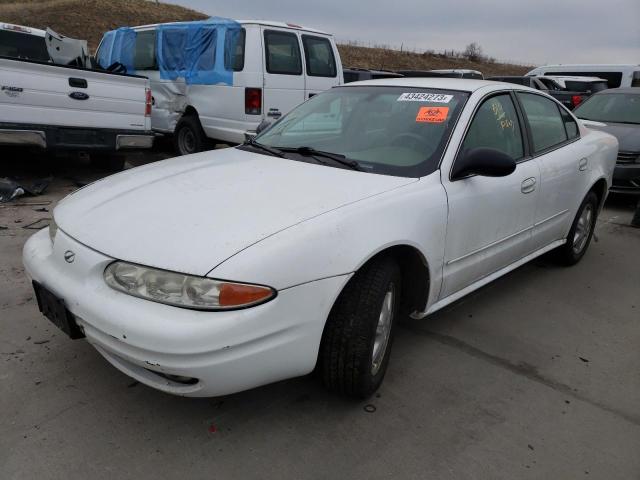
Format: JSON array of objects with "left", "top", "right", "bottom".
[{"left": 517, "top": 93, "right": 568, "bottom": 153}]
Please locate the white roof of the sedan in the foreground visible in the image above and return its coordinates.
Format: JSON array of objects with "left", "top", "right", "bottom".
[{"left": 341, "top": 77, "right": 524, "bottom": 92}]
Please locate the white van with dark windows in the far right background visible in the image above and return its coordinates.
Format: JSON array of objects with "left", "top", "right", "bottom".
[{"left": 527, "top": 65, "right": 640, "bottom": 88}]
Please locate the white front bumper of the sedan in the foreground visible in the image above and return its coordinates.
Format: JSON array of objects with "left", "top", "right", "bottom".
[{"left": 23, "top": 229, "right": 349, "bottom": 396}]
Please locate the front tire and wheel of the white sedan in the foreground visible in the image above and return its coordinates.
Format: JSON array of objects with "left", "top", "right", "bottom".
[{"left": 318, "top": 257, "right": 401, "bottom": 398}]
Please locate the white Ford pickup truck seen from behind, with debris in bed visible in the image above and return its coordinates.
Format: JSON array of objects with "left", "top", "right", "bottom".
[{"left": 0, "top": 24, "right": 154, "bottom": 169}]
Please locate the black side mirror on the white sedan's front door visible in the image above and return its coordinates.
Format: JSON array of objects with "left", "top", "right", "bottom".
[{"left": 451, "top": 148, "right": 516, "bottom": 180}]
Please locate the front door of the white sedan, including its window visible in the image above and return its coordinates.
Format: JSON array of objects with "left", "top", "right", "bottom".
[{"left": 440, "top": 93, "right": 540, "bottom": 298}]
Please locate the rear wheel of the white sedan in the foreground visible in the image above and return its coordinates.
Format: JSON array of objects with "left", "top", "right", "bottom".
[{"left": 556, "top": 192, "right": 598, "bottom": 266}]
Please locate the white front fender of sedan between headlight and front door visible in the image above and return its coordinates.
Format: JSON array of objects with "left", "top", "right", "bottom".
[{"left": 208, "top": 172, "right": 447, "bottom": 306}]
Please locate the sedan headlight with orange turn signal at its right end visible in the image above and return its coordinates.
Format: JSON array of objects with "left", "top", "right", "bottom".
[{"left": 104, "top": 261, "right": 276, "bottom": 310}]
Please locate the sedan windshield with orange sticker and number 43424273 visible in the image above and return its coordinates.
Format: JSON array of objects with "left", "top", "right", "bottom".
[{"left": 256, "top": 86, "right": 468, "bottom": 177}]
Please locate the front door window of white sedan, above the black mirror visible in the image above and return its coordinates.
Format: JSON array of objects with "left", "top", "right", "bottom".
[{"left": 461, "top": 94, "right": 524, "bottom": 160}]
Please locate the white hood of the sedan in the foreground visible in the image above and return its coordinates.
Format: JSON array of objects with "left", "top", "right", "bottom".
[{"left": 55, "top": 148, "right": 416, "bottom": 281}]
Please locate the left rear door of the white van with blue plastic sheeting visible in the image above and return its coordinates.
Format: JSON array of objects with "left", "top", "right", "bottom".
[{"left": 263, "top": 27, "right": 305, "bottom": 119}]
